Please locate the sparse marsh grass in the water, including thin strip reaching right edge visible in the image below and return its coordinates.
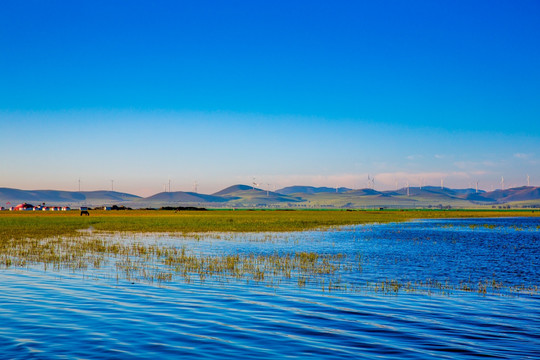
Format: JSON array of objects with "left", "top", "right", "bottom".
[{"left": 0, "top": 234, "right": 538, "bottom": 295}]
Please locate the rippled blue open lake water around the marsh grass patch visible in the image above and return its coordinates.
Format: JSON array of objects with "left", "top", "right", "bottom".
[{"left": 0, "top": 218, "right": 540, "bottom": 359}]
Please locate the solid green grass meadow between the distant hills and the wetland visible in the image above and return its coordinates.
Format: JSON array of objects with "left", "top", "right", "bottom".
[{"left": 0, "top": 210, "right": 540, "bottom": 241}]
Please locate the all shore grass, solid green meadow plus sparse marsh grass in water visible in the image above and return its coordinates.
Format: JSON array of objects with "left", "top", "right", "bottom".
[{"left": 0, "top": 211, "right": 538, "bottom": 294}]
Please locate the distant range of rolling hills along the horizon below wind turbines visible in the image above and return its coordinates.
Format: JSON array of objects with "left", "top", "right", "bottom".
[{"left": 0, "top": 184, "right": 540, "bottom": 208}]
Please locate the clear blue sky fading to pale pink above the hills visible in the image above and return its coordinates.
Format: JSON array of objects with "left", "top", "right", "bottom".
[{"left": 0, "top": 0, "right": 540, "bottom": 195}]
